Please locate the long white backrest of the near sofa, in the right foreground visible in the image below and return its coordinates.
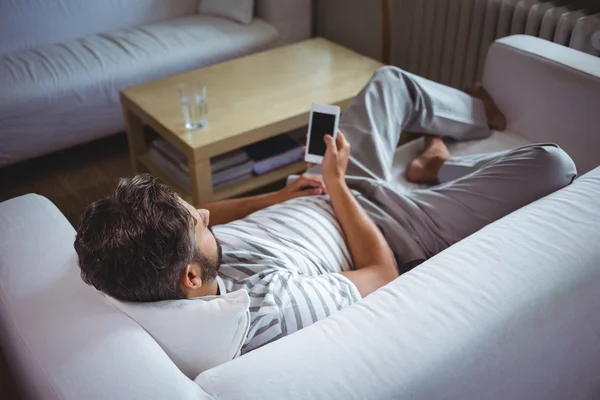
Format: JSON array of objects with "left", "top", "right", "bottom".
[{"left": 196, "top": 161, "right": 600, "bottom": 400}]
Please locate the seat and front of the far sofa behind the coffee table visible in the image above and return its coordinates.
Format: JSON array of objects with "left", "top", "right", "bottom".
[{"left": 0, "top": 15, "right": 277, "bottom": 166}]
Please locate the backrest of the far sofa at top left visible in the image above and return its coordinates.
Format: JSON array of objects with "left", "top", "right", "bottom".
[{"left": 0, "top": 0, "right": 199, "bottom": 55}]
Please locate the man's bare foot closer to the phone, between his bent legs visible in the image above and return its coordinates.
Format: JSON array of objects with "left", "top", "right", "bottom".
[{"left": 406, "top": 136, "right": 450, "bottom": 183}]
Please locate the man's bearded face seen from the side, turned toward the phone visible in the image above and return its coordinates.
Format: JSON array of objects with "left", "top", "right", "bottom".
[{"left": 179, "top": 198, "right": 223, "bottom": 283}]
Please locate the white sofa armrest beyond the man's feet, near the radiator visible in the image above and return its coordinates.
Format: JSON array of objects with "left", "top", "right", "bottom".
[{"left": 483, "top": 35, "right": 600, "bottom": 174}]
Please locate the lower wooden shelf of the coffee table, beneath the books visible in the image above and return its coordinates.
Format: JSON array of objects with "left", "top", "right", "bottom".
[{"left": 137, "top": 153, "right": 306, "bottom": 205}]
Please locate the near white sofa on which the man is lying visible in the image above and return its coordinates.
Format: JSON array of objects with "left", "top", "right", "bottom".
[{"left": 0, "top": 36, "right": 600, "bottom": 400}]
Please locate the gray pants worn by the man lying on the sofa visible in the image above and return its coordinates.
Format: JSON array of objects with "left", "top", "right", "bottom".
[{"left": 340, "top": 67, "right": 576, "bottom": 272}]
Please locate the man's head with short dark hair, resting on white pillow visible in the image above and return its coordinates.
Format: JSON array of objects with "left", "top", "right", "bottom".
[{"left": 75, "top": 175, "right": 221, "bottom": 301}]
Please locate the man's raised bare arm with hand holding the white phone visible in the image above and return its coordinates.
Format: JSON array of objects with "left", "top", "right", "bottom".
[{"left": 322, "top": 132, "right": 399, "bottom": 297}]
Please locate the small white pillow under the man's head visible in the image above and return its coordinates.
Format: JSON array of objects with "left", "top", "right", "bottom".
[{"left": 107, "top": 290, "right": 250, "bottom": 379}]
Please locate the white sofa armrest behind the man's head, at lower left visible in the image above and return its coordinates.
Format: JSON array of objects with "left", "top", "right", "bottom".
[{"left": 0, "top": 194, "right": 209, "bottom": 400}]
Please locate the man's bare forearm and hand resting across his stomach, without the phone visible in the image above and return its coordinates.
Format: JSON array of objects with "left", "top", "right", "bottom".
[{"left": 198, "top": 173, "right": 325, "bottom": 225}]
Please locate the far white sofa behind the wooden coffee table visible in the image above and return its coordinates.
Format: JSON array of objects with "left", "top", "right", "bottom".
[{"left": 0, "top": 0, "right": 311, "bottom": 167}]
